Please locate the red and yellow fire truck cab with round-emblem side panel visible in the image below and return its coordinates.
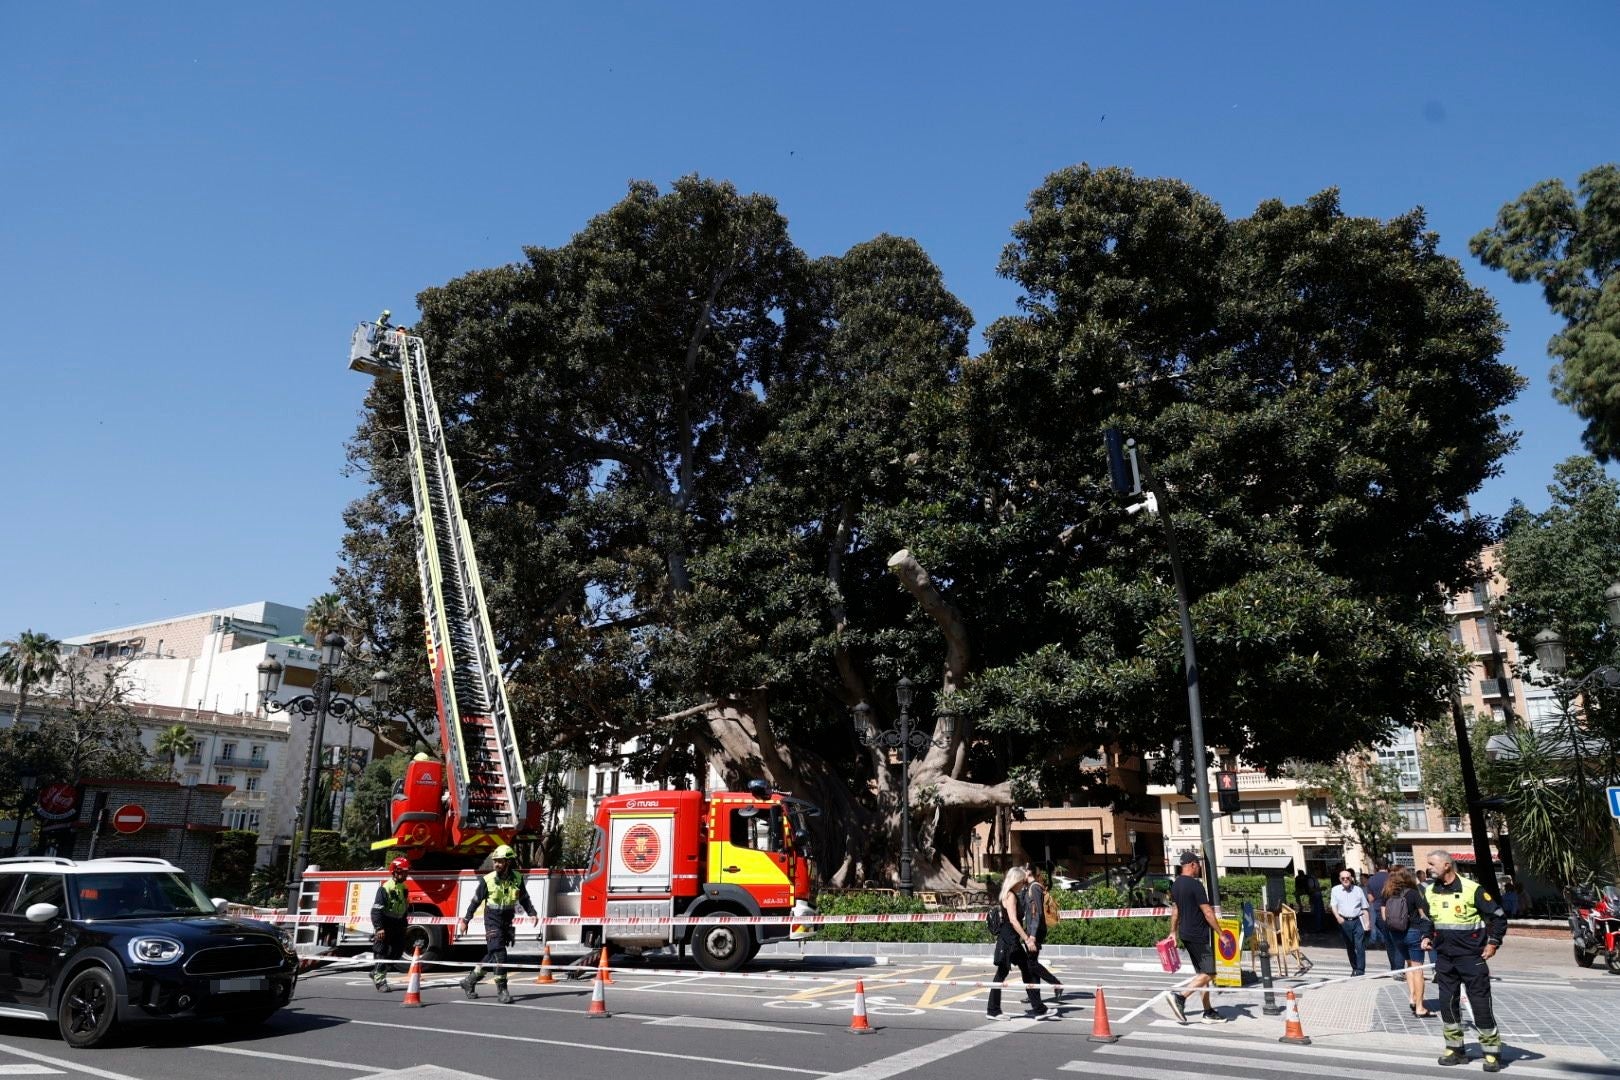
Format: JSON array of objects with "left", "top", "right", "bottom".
[{"left": 580, "top": 780, "right": 820, "bottom": 972}]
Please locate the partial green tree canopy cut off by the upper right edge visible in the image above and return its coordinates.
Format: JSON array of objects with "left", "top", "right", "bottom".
[{"left": 1469, "top": 164, "right": 1620, "bottom": 461}]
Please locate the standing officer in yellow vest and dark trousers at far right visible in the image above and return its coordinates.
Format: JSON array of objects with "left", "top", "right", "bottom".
[{"left": 1422, "top": 850, "right": 1508, "bottom": 1072}]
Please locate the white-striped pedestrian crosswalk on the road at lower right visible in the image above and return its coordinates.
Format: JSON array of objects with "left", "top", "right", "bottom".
[{"left": 1059, "top": 1028, "right": 1615, "bottom": 1080}]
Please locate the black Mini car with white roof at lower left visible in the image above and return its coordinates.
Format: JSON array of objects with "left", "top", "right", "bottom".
[{"left": 0, "top": 858, "right": 298, "bottom": 1046}]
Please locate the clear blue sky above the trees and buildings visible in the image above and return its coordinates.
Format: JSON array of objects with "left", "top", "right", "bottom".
[{"left": 0, "top": 0, "right": 1620, "bottom": 636}]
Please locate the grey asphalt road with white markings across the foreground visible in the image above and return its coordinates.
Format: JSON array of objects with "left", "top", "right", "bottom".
[{"left": 0, "top": 960, "right": 1620, "bottom": 1080}]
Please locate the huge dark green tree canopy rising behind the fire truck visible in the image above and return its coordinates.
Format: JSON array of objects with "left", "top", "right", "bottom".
[{"left": 337, "top": 167, "right": 1518, "bottom": 881}]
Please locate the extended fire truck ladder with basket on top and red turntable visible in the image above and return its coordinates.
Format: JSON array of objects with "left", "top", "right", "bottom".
[{"left": 348, "top": 322, "right": 527, "bottom": 855}]
